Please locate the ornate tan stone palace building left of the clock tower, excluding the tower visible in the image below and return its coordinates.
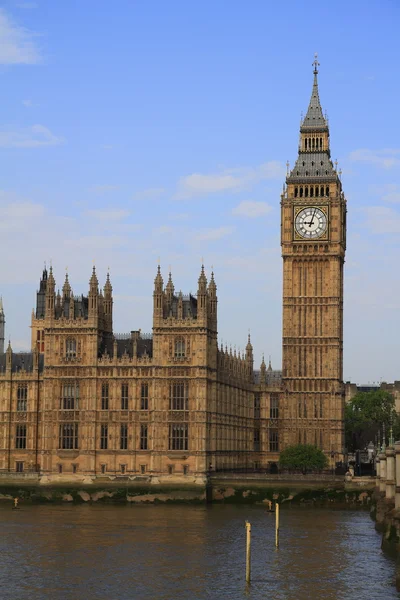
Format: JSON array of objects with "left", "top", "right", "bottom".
[{"left": 0, "top": 268, "right": 280, "bottom": 477}]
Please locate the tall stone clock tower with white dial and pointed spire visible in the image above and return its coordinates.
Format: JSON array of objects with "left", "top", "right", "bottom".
[{"left": 281, "top": 59, "right": 346, "bottom": 464}]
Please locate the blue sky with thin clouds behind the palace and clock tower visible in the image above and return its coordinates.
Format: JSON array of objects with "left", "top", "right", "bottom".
[{"left": 0, "top": 0, "right": 400, "bottom": 383}]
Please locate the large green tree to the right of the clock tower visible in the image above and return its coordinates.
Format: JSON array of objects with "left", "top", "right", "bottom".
[{"left": 344, "top": 390, "right": 400, "bottom": 451}]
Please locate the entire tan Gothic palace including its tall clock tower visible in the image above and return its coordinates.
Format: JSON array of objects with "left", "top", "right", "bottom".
[{"left": 0, "top": 61, "right": 346, "bottom": 480}]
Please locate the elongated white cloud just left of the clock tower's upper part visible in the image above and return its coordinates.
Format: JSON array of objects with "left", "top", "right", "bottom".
[{"left": 175, "top": 161, "right": 285, "bottom": 199}]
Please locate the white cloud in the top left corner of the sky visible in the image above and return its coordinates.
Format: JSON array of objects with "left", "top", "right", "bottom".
[{"left": 0, "top": 8, "right": 42, "bottom": 65}]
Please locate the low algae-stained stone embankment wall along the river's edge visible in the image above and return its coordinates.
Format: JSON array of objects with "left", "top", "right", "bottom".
[{"left": 0, "top": 474, "right": 375, "bottom": 508}]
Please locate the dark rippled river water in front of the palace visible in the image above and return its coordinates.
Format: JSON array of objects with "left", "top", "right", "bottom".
[{"left": 0, "top": 503, "right": 400, "bottom": 600}]
